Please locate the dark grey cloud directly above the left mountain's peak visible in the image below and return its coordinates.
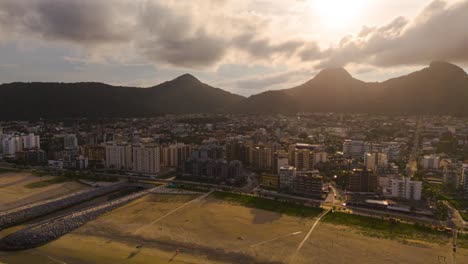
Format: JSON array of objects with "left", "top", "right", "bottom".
[{"left": 138, "top": 2, "right": 227, "bottom": 68}]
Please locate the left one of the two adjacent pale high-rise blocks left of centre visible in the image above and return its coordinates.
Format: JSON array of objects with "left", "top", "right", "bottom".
[{"left": 106, "top": 142, "right": 133, "bottom": 170}]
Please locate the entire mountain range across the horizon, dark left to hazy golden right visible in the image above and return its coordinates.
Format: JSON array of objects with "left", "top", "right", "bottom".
[{"left": 0, "top": 62, "right": 468, "bottom": 119}]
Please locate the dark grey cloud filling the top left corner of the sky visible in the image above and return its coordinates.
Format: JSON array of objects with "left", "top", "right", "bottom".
[{"left": 0, "top": 0, "right": 130, "bottom": 44}]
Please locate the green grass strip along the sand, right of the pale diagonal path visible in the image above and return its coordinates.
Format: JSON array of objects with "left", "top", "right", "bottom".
[{"left": 323, "top": 212, "right": 450, "bottom": 244}]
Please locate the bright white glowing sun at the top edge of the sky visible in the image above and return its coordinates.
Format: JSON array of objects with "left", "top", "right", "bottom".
[{"left": 310, "top": 0, "right": 369, "bottom": 29}]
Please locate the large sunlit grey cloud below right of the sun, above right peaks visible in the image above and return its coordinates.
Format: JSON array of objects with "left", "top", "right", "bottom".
[{"left": 319, "top": 1, "right": 468, "bottom": 67}]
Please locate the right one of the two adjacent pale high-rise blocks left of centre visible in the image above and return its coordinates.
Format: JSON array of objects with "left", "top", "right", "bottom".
[{"left": 133, "top": 145, "right": 160, "bottom": 174}]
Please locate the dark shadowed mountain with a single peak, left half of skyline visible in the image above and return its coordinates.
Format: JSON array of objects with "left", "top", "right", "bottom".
[{"left": 0, "top": 74, "right": 247, "bottom": 120}]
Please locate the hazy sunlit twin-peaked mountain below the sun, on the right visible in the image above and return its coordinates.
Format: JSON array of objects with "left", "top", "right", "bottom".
[{"left": 230, "top": 61, "right": 468, "bottom": 115}]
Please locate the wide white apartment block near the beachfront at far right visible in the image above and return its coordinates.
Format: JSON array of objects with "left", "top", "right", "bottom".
[{"left": 379, "top": 175, "right": 422, "bottom": 200}]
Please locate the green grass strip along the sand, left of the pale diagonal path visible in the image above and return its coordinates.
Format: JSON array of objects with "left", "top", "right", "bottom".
[{"left": 213, "top": 192, "right": 323, "bottom": 217}]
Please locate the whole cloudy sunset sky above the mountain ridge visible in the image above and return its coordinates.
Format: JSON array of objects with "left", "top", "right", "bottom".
[{"left": 0, "top": 0, "right": 468, "bottom": 96}]
